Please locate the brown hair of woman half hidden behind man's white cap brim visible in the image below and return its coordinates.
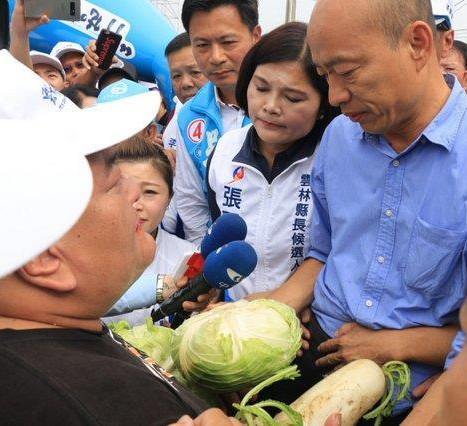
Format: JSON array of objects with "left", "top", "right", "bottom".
[{"left": 111, "top": 136, "right": 173, "bottom": 198}]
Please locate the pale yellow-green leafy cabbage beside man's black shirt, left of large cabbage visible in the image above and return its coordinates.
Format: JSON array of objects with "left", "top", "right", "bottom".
[{"left": 109, "top": 318, "right": 174, "bottom": 374}]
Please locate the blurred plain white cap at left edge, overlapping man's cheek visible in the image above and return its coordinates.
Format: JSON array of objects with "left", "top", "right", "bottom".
[{"left": 0, "top": 119, "right": 93, "bottom": 278}]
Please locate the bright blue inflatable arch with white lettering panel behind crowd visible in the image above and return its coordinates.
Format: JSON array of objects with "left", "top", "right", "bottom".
[{"left": 9, "top": 0, "right": 177, "bottom": 106}]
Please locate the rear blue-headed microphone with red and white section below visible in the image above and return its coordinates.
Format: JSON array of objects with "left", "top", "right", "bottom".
[{"left": 172, "top": 213, "right": 247, "bottom": 281}]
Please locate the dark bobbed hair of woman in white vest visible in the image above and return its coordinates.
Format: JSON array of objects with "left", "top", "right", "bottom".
[{"left": 235, "top": 22, "right": 340, "bottom": 134}]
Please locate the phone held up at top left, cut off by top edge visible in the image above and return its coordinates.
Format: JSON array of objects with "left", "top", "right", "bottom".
[{"left": 24, "top": 0, "right": 81, "bottom": 21}]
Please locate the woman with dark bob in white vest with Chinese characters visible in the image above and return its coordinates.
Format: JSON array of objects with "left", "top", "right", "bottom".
[{"left": 207, "top": 22, "right": 337, "bottom": 300}]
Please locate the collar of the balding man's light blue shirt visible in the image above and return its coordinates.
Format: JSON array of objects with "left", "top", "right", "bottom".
[{"left": 355, "top": 74, "right": 467, "bottom": 151}]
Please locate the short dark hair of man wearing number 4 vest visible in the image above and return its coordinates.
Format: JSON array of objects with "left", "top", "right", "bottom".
[{"left": 182, "top": 0, "right": 258, "bottom": 33}]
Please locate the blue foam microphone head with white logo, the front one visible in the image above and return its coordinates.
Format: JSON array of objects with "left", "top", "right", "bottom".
[{"left": 203, "top": 241, "right": 258, "bottom": 290}]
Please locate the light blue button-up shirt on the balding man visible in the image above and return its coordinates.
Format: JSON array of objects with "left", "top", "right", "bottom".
[{"left": 308, "top": 79, "right": 467, "bottom": 410}]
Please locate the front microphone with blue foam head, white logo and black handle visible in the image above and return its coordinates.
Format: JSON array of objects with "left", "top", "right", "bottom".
[{"left": 151, "top": 241, "right": 258, "bottom": 322}]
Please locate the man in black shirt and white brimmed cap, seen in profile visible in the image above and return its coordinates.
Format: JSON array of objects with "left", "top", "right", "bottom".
[{"left": 0, "top": 52, "right": 214, "bottom": 425}]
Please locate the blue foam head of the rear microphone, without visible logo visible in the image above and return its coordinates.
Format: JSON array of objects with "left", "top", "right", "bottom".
[{"left": 200, "top": 213, "right": 247, "bottom": 259}]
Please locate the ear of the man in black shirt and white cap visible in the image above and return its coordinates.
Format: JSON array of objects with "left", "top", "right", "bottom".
[{"left": 18, "top": 247, "right": 77, "bottom": 292}]
